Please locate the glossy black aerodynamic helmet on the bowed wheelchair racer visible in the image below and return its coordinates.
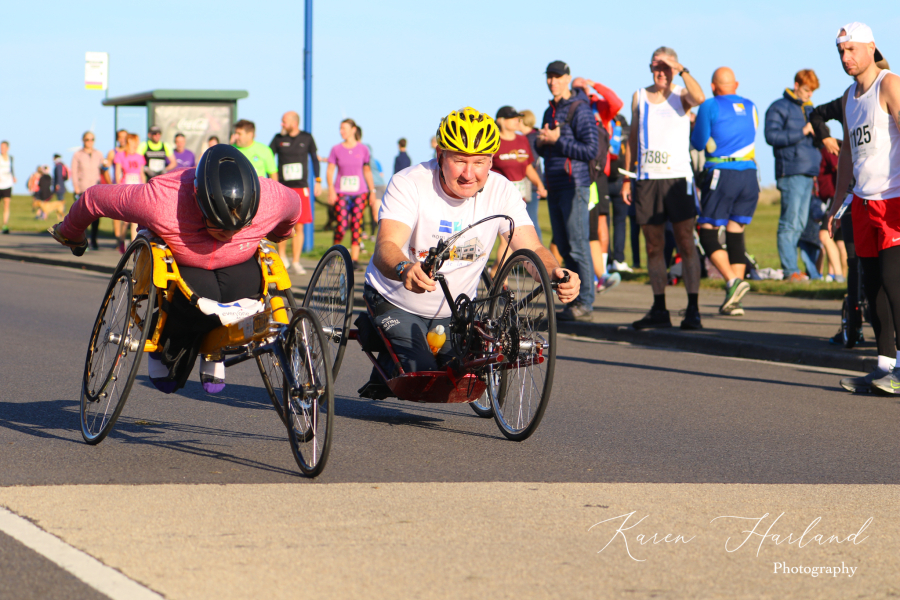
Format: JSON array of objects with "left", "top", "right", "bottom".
[{"left": 194, "top": 144, "right": 259, "bottom": 231}]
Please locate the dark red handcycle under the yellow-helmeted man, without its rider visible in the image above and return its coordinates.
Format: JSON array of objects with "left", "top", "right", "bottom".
[{"left": 303, "top": 215, "right": 568, "bottom": 441}]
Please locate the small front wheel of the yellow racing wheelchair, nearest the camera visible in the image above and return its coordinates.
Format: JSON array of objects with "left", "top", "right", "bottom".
[{"left": 283, "top": 308, "right": 334, "bottom": 477}]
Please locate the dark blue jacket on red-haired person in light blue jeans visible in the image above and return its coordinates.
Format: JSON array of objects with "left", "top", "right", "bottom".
[{"left": 766, "top": 90, "right": 822, "bottom": 179}]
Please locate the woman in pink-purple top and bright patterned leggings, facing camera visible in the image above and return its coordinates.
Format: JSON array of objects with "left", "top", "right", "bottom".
[{"left": 326, "top": 119, "right": 376, "bottom": 268}]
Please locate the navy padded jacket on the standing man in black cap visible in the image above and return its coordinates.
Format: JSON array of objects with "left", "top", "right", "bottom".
[{"left": 537, "top": 90, "right": 596, "bottom": 191}]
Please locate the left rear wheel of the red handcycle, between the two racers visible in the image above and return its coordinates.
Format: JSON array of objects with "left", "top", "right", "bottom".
[{"left": 303, "top": 245, "right": 353, "bottom": 380}]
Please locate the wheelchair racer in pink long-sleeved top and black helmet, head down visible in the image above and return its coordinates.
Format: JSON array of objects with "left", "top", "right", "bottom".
[{"left": 51, "top": 144, "right": 302, "bottom": 394}]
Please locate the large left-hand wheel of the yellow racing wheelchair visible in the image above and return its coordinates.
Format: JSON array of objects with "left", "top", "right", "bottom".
[{"left": 80, "top": 237, "right": 156, "bottom": 444}]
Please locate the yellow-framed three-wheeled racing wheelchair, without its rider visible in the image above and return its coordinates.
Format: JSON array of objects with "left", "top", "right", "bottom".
[{"left": 80, "top": 231, "right": 334, "bottom": 477}]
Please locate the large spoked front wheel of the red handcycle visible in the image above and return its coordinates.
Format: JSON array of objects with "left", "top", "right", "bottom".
[{"left": 488, "top": 249, "right": 556, "bottom": 442}]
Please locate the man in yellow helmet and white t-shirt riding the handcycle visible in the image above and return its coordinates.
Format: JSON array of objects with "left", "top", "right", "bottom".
[{"left": 359, "top": 108, "right": 581, "bottom": 398}]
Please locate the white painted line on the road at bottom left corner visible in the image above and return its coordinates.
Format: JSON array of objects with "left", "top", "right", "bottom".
[{"left": 0, "top": 507, "right": 163, "bottom": 600}]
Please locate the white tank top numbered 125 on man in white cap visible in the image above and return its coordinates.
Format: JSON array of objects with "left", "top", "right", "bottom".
[{"left": 845, "top": 70, "right": 900, "bottom": 200}]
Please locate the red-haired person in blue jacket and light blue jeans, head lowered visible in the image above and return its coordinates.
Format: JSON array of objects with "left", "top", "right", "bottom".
[{"left": 766, "top": 69, "right": 822, "bottom": 281}]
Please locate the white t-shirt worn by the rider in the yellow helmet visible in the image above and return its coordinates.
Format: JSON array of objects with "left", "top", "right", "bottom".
[{"left": 366, "top": 159, "right": 532, "bottom": 319}]
